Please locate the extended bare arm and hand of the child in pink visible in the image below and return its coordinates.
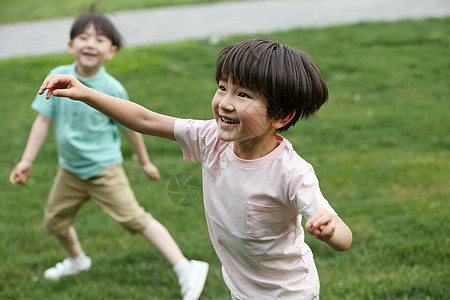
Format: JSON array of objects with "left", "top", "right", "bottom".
[{"left": 39, "top": 74, "right": 175, "bottom": 140}]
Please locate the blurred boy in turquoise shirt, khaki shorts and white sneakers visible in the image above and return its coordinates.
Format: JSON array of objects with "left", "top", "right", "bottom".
[{"left": 10, "top": 14, "right": 208, "bottom": 299}]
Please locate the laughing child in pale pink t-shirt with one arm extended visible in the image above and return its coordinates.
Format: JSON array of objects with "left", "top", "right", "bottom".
[{"left": 39, "top": 38, "right": 352, "bottom": 300}]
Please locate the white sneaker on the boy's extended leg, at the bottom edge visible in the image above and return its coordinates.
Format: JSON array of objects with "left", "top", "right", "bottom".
[{"left": 179, "top": 260, "right": 209, "bottom": 300}]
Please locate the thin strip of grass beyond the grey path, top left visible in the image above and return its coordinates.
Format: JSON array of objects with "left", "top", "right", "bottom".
[{"left": 0, "top": 0, "right": 235, "bottom": 24}]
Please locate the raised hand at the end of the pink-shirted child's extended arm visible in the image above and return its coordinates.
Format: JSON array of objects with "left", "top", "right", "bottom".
[{"left": 39, "top": 74, "right": 86, "bottom": 100}]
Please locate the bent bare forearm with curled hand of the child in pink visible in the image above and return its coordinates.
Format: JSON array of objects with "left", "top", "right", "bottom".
[{"left": 305, "top": 208, "right": 353, "bottom": 251}]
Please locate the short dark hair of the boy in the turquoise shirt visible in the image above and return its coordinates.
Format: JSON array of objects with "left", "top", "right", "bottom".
[{"left": 70, "top": 13, "right": 123, "bottom": 49}]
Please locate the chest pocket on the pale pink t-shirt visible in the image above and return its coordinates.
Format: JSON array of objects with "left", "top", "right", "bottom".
[{"left": 246, "top": 202, "right": 296, "bottom": 238}]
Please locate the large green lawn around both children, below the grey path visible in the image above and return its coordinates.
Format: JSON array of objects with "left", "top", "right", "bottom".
[{"left": 0, "top": 18, "right": 450, "bottom": 300}]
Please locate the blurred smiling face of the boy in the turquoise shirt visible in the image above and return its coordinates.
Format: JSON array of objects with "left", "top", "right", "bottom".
[{"left": 69, "top": 23, "right": 117, "bottom": 77}]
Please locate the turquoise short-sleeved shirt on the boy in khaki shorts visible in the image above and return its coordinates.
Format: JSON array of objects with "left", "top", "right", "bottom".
[{"left": 31, "top": 63, "right": 128, "bottom": 179}]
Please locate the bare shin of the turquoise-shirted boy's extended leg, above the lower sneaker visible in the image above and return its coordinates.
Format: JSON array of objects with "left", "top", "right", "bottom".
[{"left": 142, "top": 219, "right": 184, "bottom": 267}]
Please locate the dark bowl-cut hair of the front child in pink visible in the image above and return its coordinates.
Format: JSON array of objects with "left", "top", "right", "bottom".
[{"left": 216, "top": 38, "right": 328, "bottom": 131}]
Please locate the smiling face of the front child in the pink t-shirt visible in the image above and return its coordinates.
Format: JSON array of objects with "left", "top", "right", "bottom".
[{"left": 212, "top": 80, "right": 286, "bottom": 159}]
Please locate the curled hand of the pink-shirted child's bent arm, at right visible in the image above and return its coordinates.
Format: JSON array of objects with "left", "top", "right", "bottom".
[{"left": 305, "top": 208, "right": 336, "bottom": 241}]
